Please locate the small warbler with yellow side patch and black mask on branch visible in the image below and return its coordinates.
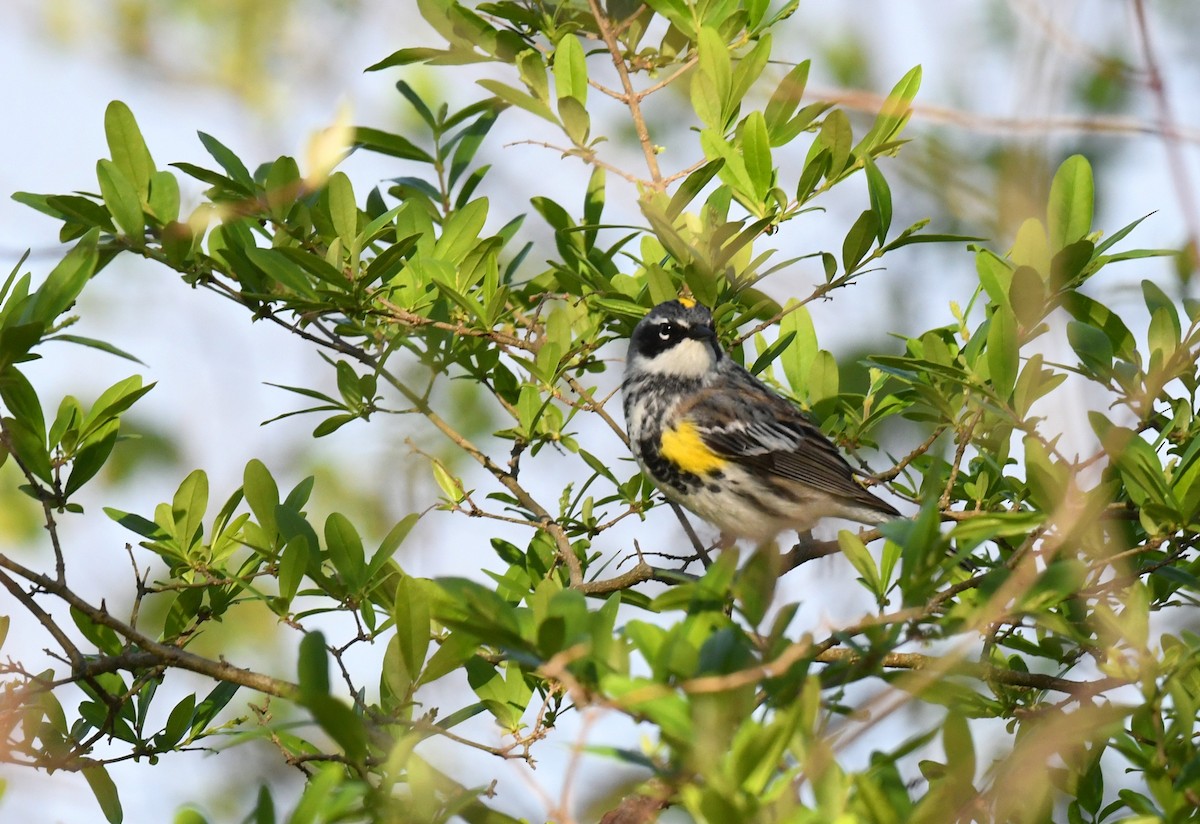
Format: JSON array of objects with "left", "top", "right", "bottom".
[{"left": 623, "top": 297, "right": 900, "bottom": 542}]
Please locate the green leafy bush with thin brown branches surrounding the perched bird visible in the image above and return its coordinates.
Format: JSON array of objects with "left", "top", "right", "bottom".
[{"left": 0, "top": 0, "right": 1200, "bottom": 822}]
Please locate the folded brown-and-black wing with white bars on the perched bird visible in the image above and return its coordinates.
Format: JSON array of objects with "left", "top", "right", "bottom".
[{"left": 686, "top": 375, "right": 894, "bottom": 512}]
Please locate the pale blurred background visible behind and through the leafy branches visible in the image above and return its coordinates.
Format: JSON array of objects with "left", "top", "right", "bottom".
[{"left": 0, "top": 0, "right": 1200, "bottom": 822}]
